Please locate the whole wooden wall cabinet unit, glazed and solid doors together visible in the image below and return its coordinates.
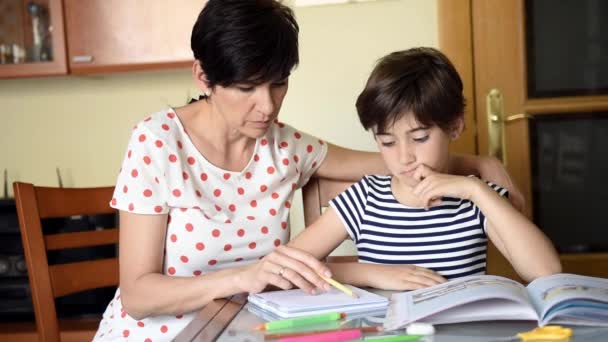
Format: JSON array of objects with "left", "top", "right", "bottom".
[{"left": 0, "top": 0, "right": 206, "bottom": 78}]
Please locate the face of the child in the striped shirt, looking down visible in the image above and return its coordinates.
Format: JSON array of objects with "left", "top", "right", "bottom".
[{"left": 375, "top": 112, "right": 460, "bottom": 187}]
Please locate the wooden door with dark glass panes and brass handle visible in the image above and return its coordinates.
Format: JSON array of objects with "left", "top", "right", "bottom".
[{"left": 471, "top": 0, "right": 608, "bottom": 277}]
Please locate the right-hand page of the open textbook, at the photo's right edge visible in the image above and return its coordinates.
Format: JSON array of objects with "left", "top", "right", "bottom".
[{"left": 528, "top": 273, "right": 608, "bottom": 325}]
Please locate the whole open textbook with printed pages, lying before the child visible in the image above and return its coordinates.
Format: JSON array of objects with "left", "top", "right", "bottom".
[{"left": 384, "top": 274, "right": 608, "bottom": 330}]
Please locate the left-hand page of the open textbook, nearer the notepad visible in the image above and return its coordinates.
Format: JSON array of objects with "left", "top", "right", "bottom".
[{"left": 384, "top": 275, "right": 538, "bottom": 329}]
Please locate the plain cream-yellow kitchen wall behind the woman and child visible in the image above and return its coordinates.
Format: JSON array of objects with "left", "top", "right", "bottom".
[{"left": 0, "top": 0, "right": 437, "bottom": 254}]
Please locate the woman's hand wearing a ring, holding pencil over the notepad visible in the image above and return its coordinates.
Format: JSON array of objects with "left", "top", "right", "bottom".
[{"left": 239, "top": 246, "right": 331, "bottom": 294}]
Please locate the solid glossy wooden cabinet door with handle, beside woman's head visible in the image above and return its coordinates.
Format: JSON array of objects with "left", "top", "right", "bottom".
[{"left": 64, "top": 0, "right": 205, "bottom": 74}]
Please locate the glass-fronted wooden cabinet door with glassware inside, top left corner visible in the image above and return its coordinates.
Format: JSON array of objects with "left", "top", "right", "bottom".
[{"left": 0, "top": 0, "right": 67, "bottom": 78}]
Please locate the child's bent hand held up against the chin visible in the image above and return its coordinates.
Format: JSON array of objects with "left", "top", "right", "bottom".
[{"left": 413, "top": 165, "right": 480, "bottom": 207}]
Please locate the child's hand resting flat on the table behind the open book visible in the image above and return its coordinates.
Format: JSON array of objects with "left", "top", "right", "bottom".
[{"left": 366, "top": 264, "right": 447, "bottom": 291}]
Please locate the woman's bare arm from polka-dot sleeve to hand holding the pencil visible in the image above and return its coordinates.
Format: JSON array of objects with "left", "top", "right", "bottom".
[{"left": 119, "top": 211, "right": 329, "bottom": 319}]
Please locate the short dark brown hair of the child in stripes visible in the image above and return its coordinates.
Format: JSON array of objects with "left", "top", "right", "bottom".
[{"left": 357, "top": 47, "right": 465, "bottom": 133}]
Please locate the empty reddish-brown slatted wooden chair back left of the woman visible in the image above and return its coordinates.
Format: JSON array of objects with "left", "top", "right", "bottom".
[{"left": 13, "top": 182, "right": 118, "bottom": 341}]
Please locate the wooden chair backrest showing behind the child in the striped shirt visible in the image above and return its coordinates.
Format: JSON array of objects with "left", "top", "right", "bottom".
[{"left": 302, "top": 177, "right": 357, "bottom": 262}]
